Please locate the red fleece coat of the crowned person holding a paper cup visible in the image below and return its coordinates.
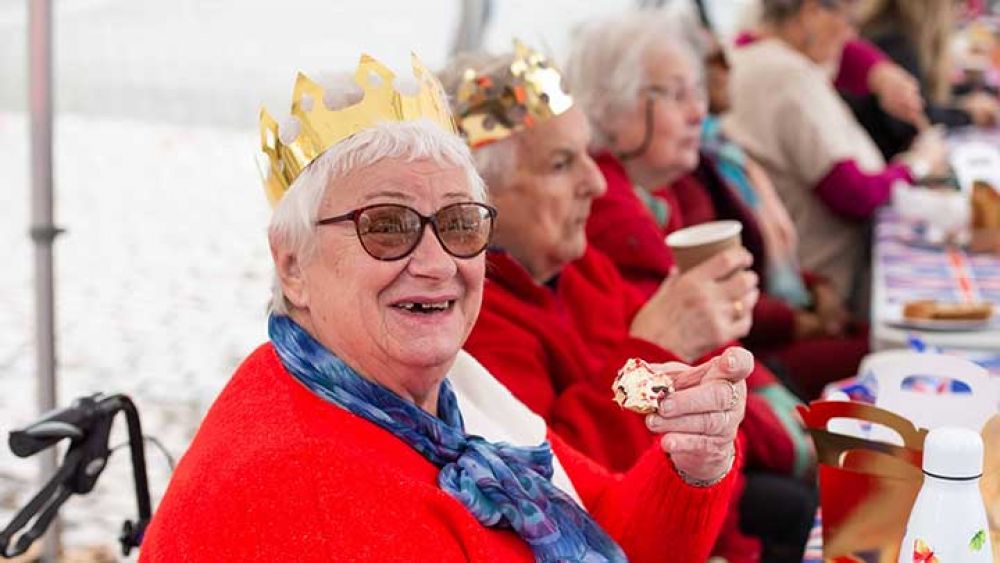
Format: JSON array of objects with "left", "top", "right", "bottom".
[{"left": 465, "top": 248, "right": 794, "bottom": 478}]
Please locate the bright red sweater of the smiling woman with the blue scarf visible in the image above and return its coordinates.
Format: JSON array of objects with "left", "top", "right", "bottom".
[{"left": 140, "top": 344, "right": 736, "bottom": 562}]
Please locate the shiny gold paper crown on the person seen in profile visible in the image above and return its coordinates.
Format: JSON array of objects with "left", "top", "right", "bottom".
[{"left": 455, "top": 39, "right": 573, "bottom": 148}]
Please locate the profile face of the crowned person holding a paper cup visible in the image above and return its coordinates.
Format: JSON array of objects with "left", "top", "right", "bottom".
[{"left": 492, "top": 107, "right": 606, "bottom": 282}]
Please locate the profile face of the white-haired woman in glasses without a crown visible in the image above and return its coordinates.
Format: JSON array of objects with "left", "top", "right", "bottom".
[{"left": 612, "top": 44, "right": 707, "bottom": 182}]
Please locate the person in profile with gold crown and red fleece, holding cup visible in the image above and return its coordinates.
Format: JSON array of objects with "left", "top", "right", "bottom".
[{"left": 444, "top": 46, "right": 815, "bottom": 561}]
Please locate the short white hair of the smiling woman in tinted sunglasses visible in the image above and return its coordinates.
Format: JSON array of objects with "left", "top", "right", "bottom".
[{"left": 268, "top": 119, "right": 486, "bottom": 314}]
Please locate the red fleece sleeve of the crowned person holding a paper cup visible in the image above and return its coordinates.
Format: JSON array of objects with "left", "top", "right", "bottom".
[{"left": 465, "top": 310, "right": 677, "bottom": 469}]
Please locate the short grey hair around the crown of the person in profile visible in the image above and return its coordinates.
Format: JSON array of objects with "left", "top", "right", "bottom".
[{"left": 438, "top": 51, "right": 520, "bottom": 192}]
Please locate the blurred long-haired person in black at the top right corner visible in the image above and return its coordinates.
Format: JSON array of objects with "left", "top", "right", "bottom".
[{"left": 848, "top": 0, "right": 1000, "bottom": 158}]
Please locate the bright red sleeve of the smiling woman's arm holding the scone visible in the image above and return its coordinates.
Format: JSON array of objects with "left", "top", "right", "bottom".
[{"left": 549, "top": 430, "right": 741, "bottom": 562}]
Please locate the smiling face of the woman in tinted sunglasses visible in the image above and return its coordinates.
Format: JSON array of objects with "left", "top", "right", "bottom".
[{"left": 276, "top": 159, "right": 485, "bottom": 382}]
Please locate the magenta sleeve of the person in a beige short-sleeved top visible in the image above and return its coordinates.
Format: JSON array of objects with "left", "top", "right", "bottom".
[{"left": 815, "top": 160, "right": 912, "bottom": 219}]
